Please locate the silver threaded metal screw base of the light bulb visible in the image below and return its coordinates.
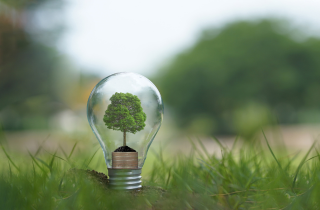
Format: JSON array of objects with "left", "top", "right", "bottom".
[{"left": 108, "top": 168, "right": 142, "bottom": 190}]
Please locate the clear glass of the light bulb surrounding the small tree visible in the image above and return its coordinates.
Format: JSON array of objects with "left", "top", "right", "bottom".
[{"left": 87, "top": 73, "right": 163, "bottom": 168}]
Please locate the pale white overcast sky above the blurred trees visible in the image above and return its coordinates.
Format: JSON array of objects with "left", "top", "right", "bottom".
[{"left": 58, "top": 0, "right": 320, "bottom": 76}]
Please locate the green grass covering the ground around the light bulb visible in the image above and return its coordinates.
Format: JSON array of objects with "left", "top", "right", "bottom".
[{"left": 0, "top": 132, "right": 320, "bottom": 210}]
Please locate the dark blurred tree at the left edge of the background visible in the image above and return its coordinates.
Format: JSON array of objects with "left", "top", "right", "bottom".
[{"left": 0, "top": 0, "right": 84, "bottom": 130}]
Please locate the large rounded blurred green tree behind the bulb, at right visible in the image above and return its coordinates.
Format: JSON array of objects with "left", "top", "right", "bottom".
[{"left": 155, "top": 20, "right": 320, "bottom": 135}]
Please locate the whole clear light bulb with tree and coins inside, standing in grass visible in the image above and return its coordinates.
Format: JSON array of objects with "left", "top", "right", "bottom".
[{"left": 87, "top": 73, "right": 163, "bottom": 190}]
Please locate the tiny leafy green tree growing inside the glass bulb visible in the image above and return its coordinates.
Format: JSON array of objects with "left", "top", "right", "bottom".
[{"left": 103, "top": 93, "right": 147, "bottom": 146}]
